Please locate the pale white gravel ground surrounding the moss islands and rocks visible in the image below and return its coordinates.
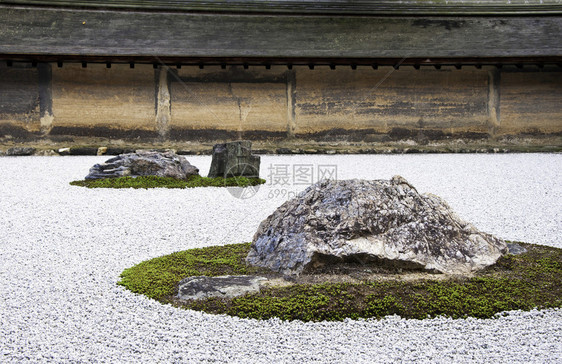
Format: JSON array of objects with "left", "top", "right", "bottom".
[{"left": 0, "top": 154, "right": 562, "bottom": 363}]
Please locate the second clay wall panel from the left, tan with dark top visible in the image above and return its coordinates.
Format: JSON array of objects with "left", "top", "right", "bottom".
[{"left": 52, "top": 64, "right": 156, "bottom": 130}]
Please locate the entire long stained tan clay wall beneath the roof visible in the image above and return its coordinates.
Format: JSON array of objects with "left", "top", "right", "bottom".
[{"left": 0, "top": 63, "right": 562, "bottom": 141}]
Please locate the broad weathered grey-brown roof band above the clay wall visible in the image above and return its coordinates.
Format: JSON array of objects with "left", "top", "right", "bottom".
[{"left": 0, "top": 5, "right": 562, "bottom": 59}]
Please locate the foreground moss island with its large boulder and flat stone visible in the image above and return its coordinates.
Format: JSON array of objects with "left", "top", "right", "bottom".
[{"left": 119, "top": 176, "right": 562, "bottom": 321}]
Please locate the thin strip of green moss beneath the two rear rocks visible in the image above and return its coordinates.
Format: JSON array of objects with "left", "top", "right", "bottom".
[{"left": 70, "top": 176, "right": 265, "bottom": 188}]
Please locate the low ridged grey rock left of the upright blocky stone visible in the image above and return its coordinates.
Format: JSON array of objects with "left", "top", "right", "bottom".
[{"left": 86, "top": 150, "right": 199, "bottom": 179}]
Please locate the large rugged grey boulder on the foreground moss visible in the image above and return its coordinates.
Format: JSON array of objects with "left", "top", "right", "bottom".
[{"left": 246, "top": 176, "right": 508, "bottom": 275}]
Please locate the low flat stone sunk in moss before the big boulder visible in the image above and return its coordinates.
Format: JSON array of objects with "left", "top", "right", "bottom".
[{"left": 177, "top": 276, "right": 267, "bottom": 300}]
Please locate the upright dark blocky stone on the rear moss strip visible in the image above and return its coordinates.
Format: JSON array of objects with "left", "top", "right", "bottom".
[{"left": 208, "top": 140, "right": 260, "bottom": 178}]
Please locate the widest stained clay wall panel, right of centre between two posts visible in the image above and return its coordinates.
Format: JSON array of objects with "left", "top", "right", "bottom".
[{"left": 290, "top": 67, "right": 488, "bottom": 134}]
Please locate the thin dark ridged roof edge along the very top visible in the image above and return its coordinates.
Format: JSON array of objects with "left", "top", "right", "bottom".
[{"left": 0, "top": 0, "right": 562, "bottom": 16}]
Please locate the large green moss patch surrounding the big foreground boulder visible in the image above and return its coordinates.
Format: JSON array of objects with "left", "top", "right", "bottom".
[{"left": 118, "top": 243, "right": 562, "bottom": 321}]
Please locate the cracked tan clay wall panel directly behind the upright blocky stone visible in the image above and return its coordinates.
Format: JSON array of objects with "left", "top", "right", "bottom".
[{"left": 170, "top": 66, "right": 287, "bottom": 132}]
